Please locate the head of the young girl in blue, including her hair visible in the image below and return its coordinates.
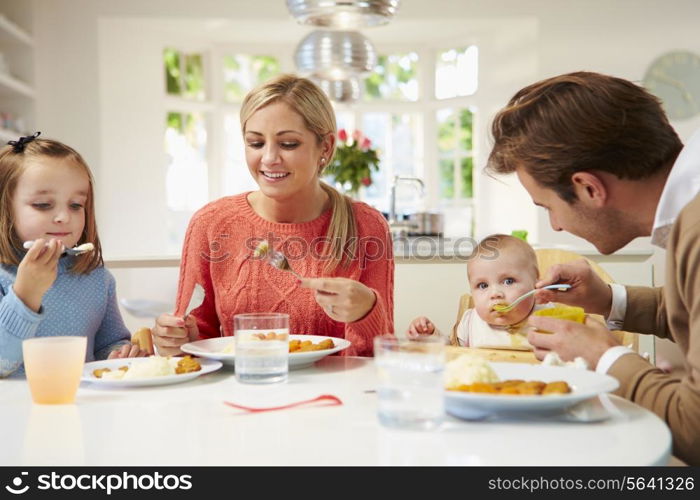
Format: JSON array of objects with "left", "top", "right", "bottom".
[{"left": 0, "top": 137, "right": 102, "bottom": 273}]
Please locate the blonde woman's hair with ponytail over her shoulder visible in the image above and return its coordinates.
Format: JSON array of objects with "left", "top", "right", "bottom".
[{"left": 240, "top": 75, "right": 357, "bottom": 273}]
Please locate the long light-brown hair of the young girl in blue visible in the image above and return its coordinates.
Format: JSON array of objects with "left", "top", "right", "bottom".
[{"left": 0, "top": 139, "right": 104, "bottom": 274}]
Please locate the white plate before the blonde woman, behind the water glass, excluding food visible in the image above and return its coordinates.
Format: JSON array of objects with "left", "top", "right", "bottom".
[{"left": 180, "top": 335, "right": 352, "bottom": 370}]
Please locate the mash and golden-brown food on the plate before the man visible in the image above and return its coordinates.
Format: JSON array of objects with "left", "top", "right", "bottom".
[{"left": 445, "top": 354, "right": 571, "bottom": 396}]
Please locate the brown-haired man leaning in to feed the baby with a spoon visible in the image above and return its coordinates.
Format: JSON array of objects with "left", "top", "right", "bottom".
[{"left": 488, "top": 72, "right": 700, "bottom": 465}]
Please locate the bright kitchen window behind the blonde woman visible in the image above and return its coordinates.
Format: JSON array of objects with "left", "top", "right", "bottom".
[{"left": 163, "top": 46, "right": 478, "bottom": 247}]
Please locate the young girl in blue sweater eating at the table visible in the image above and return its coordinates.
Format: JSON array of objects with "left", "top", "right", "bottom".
[{"left": 0, "top": 132, "right": 146, "bottom": 375}]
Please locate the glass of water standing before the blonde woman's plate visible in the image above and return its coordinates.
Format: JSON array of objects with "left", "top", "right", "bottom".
[{"left": 233, "top": 313, "right": 289, "bottom": 384}]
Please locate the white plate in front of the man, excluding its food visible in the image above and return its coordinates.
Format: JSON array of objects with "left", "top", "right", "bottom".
[{"left": 445, "top": 363, "right": 619, "bottom": 420}]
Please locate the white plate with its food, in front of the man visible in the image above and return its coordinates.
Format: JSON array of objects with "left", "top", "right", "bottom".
[{"left": 445, "top": 355, "right": 619, "bottom": 420}]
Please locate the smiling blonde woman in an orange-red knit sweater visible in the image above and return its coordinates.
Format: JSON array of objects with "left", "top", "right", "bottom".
[{"left": 153, "top": 75, "right": 394, "bottom": 356}]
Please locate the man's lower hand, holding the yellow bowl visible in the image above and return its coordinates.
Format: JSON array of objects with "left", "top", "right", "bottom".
[{"left": 527, "top": 316, "right": 620, "bottom": 370}]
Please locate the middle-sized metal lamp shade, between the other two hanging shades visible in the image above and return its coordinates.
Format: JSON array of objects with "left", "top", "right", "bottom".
[{"left": 294, "top": 30, "right": 377, "bottom": 80}]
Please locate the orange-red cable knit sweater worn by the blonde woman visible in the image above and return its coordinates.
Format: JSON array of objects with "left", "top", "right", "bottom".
[{"left": 175, "top": 193, "right": 394, "bottom": 356}]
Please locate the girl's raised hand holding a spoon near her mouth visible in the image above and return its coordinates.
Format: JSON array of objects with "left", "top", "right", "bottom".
[{"left": 12, "top": 238, "right": 63, "bottom": 312}]
